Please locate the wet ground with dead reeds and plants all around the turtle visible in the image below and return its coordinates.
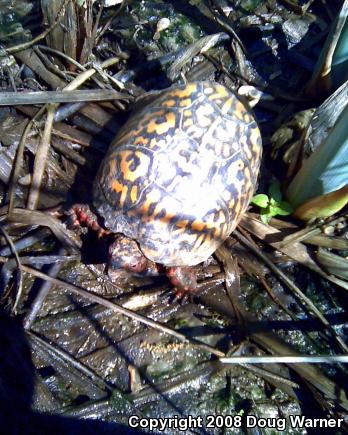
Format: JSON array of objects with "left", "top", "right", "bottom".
[{"left": 0, "top": 0, "right": 348, "bottom": 435}]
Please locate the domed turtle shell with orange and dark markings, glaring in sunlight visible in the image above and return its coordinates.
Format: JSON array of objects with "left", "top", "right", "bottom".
[{"left": 94, "top": 82, "right": 262, "bottom": 266}]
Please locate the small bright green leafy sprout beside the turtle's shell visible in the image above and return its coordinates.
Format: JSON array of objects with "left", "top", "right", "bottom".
[{"left": 251, "top": 181, "right": 293, "bottom": 224}]
